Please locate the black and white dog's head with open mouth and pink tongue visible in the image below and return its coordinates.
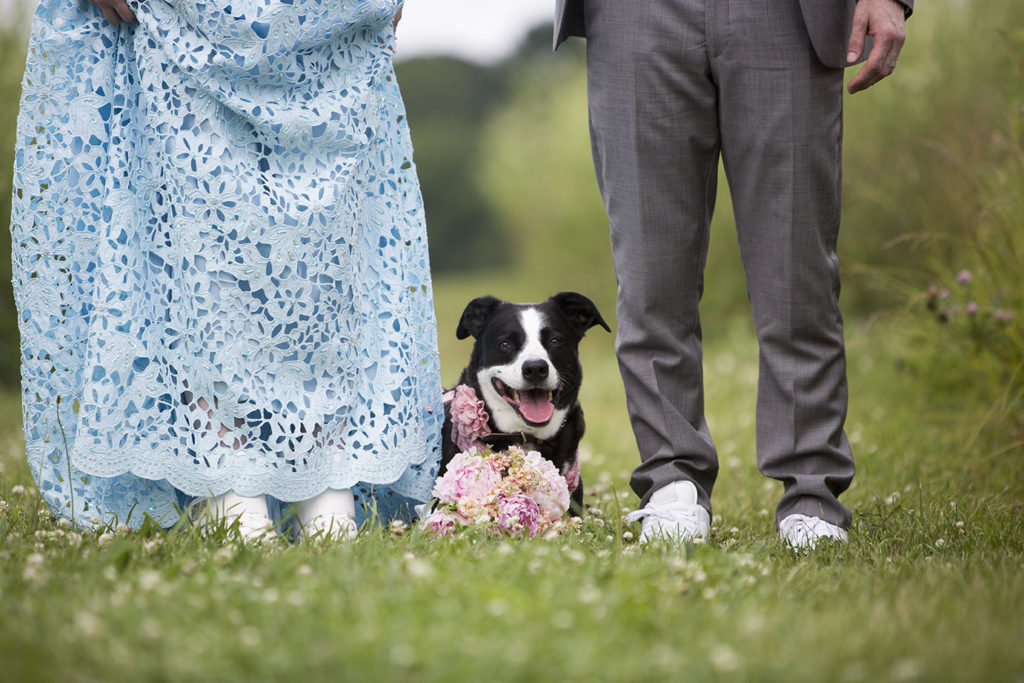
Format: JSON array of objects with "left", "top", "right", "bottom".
[{"left": 456, "top": 292, "right": 610, "bottom": 439}]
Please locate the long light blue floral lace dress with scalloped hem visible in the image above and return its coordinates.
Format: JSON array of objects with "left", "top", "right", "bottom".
[{"left": 11, "top": 0, "right": 442, "bottom": 526}]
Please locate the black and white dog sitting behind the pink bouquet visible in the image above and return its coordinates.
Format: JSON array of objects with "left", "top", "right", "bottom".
[{"left": 440, "top": 292, "right": 611, "bottom": 513}]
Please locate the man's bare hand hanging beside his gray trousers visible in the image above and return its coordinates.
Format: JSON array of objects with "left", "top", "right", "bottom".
[{"left": 846, "top": 0, "right": 906, "bottom": 93}]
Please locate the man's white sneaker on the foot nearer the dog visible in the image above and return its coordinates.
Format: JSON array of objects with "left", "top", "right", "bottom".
[{"left": 626, "top": 481, "right": 711, "bottom": 544}]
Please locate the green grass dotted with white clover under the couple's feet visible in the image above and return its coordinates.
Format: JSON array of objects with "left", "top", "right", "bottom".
[{"left": 0, "top": 307, "right": 1024, "bottom": 681}]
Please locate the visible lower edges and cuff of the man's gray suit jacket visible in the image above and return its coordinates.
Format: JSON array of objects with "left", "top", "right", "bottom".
[{"left": 555, "top": 0, "right": 913, "bottom": 69}]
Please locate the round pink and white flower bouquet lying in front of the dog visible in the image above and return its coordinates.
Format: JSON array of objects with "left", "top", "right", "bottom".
[{"left": 424, "top": 446, "right": 569, "bottom": 538}]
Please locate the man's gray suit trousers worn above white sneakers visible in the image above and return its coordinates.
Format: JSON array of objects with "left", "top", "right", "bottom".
[{"left": 585, "top": 0, "right": 854, "bottom": 527}]
